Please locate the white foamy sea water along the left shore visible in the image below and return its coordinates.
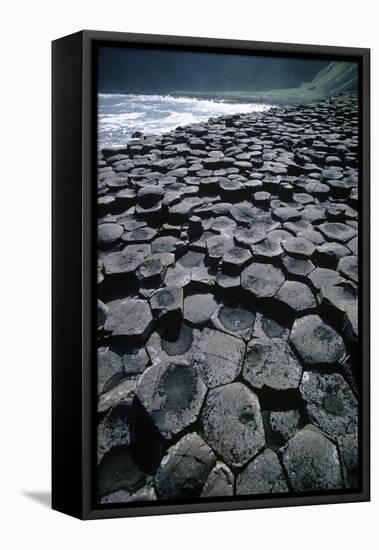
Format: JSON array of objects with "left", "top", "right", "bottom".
[{"left": 98, "top": 94, "right": 270, "bottom": 147}]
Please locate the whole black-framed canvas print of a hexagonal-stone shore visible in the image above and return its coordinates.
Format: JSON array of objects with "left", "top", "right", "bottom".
[{"left": 52, "top": 31, "right": 369, "bottom": 519}]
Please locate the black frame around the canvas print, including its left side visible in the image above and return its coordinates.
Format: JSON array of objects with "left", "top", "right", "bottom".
[{"left": 52, "top": 30, "right": 370, "bottom": 519}]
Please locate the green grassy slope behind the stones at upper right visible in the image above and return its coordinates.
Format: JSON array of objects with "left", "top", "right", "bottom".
[{"left": 172, "top": 61, "right": 358, "bottom": 104}]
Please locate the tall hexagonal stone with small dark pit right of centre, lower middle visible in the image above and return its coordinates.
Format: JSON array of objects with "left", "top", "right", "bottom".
[{"left": 201, "top": 382, "right": 265, "bottom": 467}]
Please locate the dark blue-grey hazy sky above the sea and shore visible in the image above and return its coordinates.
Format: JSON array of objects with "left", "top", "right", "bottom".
[{"left": 98, "top": 46, "right": 329, "bottom": 93}]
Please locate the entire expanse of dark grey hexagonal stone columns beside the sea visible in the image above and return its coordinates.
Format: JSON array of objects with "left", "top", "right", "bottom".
[{"left": 97, "top": 95, "right": 360, "bottom": 504}]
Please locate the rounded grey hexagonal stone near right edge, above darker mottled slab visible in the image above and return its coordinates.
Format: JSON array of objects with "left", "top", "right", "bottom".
[{"left": 290, "top": 315, "right": 345, "bottom": 365}]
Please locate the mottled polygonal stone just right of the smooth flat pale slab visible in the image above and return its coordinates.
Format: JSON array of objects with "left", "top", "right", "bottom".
[{"left": 242, "top": 338, "right": 303, "bottom": 390}]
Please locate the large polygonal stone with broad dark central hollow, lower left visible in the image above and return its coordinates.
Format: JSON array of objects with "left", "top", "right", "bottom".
[{"left": 136, "top": 362, "right": 207, "bottom": 439}]
